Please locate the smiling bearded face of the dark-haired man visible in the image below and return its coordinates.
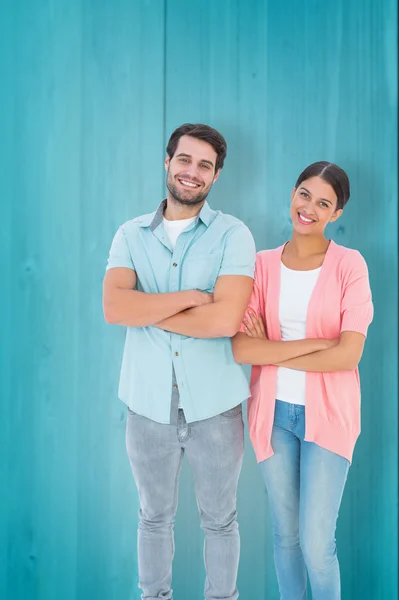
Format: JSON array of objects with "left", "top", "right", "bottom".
[{"left": 165, "top": 135, "right": 219, "bottom": 206}]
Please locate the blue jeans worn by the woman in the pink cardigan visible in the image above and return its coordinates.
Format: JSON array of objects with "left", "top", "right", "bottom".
[{"left": 260, "top": 400, "right": 349, "bottom": 600}]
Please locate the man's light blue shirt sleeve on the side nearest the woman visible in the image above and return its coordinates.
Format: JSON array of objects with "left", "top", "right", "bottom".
[{"left": 219, "top": 224, "right": 256, "bottom": 278}]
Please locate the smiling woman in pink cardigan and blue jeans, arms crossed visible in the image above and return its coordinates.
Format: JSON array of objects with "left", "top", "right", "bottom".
[{"left": 233, "top": 162, "right": 373, "bottom": 600}]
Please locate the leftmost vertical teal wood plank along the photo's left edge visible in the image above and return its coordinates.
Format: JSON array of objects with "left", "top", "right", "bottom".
[{"left": 1, "top": 1, "right": 80, "bottom": 599}]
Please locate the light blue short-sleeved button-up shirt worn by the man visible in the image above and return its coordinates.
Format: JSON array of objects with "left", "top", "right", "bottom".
[{"left": 107, "top": 200, "right": 256, "bottom": 423}]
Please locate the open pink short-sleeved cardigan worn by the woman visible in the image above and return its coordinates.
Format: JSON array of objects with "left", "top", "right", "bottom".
[{"left": 248, "top": 241, "right": 373, "bottom": 462}]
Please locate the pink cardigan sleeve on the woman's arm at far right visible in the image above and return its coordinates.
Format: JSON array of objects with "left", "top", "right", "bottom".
[{"left": 341, "top": 251, "right": 374, "bottom": 336}]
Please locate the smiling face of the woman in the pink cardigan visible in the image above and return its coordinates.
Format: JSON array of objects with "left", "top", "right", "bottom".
[{"left": 290, "top": 177, "right": 342, "bottom": 236}]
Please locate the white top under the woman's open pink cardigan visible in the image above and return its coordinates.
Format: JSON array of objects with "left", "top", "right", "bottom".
[{"left": 276, "top": 263, "right": 321, "bottom": 405}]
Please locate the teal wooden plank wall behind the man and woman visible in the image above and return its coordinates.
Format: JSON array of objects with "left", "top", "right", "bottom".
[{"left": 0, "top": 0, "right": 398, "bottom": 600}]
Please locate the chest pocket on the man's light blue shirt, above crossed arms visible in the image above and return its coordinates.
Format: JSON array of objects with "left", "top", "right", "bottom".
[{"left": 181, "top": 253, "right": 221, "bottom": 292}]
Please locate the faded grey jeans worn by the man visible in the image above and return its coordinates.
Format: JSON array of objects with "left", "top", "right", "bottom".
[{"left": 126, "top": 405, "right": 244, "bottom": 600}]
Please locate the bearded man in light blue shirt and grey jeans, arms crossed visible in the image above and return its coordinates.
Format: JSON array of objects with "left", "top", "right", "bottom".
[{"left": 104, "top": 124, "right": 255, "bottom": 600}]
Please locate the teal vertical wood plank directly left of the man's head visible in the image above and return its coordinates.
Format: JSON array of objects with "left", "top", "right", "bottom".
[{"left": 77, "top": 0, "right": 164, "bottom": 600}]
